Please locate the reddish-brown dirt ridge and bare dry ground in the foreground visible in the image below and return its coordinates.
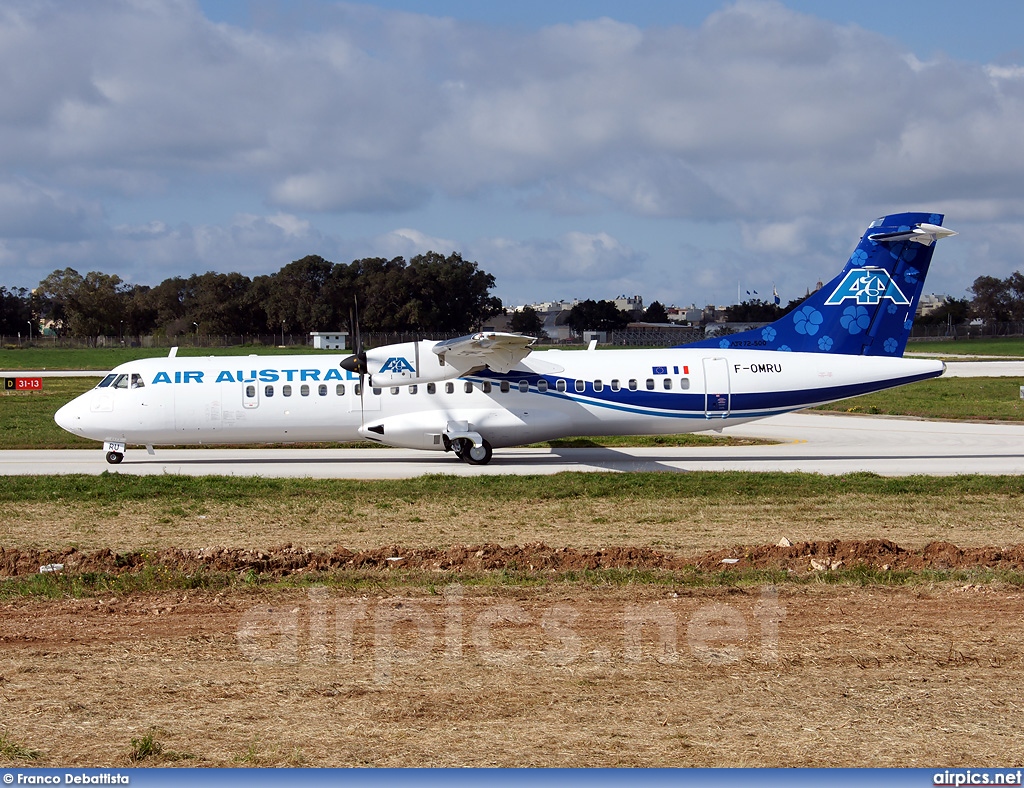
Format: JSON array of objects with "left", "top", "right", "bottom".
[{"left": 0, "top": 540, "right": 1024, "bottom": 767}]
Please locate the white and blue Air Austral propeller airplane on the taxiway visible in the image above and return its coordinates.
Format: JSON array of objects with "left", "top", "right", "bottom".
[{"left": 54, "top": 213, "right": 956, "bottom": 465}]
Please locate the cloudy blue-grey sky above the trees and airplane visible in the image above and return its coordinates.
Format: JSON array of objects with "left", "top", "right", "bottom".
[{"left": 0, "top": 0, "right": 1024, "bottom": 306}]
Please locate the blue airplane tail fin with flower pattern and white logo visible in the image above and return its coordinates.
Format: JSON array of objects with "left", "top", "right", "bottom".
[{"left": 687, "top": 213, "right": 956, "bottom": 356}]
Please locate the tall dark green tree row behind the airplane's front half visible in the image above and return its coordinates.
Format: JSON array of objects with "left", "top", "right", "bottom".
[{"left": 0, "top": 252, "right": 502, "bottom": 338}]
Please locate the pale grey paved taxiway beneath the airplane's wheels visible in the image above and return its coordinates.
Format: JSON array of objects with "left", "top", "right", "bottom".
[{"left": 8, "top": 412, "right": 1024, "bottom": 479}]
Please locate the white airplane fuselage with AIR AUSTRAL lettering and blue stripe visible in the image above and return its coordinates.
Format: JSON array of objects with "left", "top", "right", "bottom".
[{"left": 55, "top": 347, "right": 944, "bottom": 450}]
